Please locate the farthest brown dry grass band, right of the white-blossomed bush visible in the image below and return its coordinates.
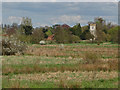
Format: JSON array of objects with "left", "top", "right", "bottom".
[{"left": 26, "top": 45, "right": 118, "bottom": 58}]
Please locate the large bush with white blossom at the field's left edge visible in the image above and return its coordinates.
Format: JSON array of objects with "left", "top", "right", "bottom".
[{"left": 0, "top": 37, "right": 27, "bottom": 55}]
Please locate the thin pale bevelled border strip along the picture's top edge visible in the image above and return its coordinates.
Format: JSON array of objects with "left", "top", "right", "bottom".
[{"left": 3, "top": 0, "right": 119, "bottom": 2}]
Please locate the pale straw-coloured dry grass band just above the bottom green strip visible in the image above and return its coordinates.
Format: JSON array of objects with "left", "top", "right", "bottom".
[{"left": 4, "top": 71, "right": 118, "bottom": 83}]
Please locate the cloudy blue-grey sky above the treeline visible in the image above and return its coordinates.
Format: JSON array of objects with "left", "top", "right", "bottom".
[{"left": 2, "top": 0, "right": 118, "bottom": 27}]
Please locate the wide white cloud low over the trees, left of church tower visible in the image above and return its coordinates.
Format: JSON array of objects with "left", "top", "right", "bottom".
[{"left": 51, "top": 15, "right": 87, "bottom": 24}]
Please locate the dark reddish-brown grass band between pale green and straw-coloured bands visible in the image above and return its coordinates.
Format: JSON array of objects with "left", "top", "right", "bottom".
[{"left": 2, "top": 60, "right": 118, "bottom": 74}]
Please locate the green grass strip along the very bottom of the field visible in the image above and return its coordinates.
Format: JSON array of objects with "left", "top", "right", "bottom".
[{"left": 2, "top": 78, "right": 118, "bottom": 88}]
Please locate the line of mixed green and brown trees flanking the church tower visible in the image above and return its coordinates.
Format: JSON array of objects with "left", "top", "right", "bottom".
[{"left": 2, "top": 17, "right": 118, "bottom": 44}]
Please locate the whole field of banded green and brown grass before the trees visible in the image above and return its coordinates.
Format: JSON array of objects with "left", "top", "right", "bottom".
[{"left": 2, "top": 43, "right": 119, "bottom": 88}]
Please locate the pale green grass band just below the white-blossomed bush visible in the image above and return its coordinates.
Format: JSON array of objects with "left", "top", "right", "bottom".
[{"left": 2, "top": 56, "right": 81, "bottom": 67}]
